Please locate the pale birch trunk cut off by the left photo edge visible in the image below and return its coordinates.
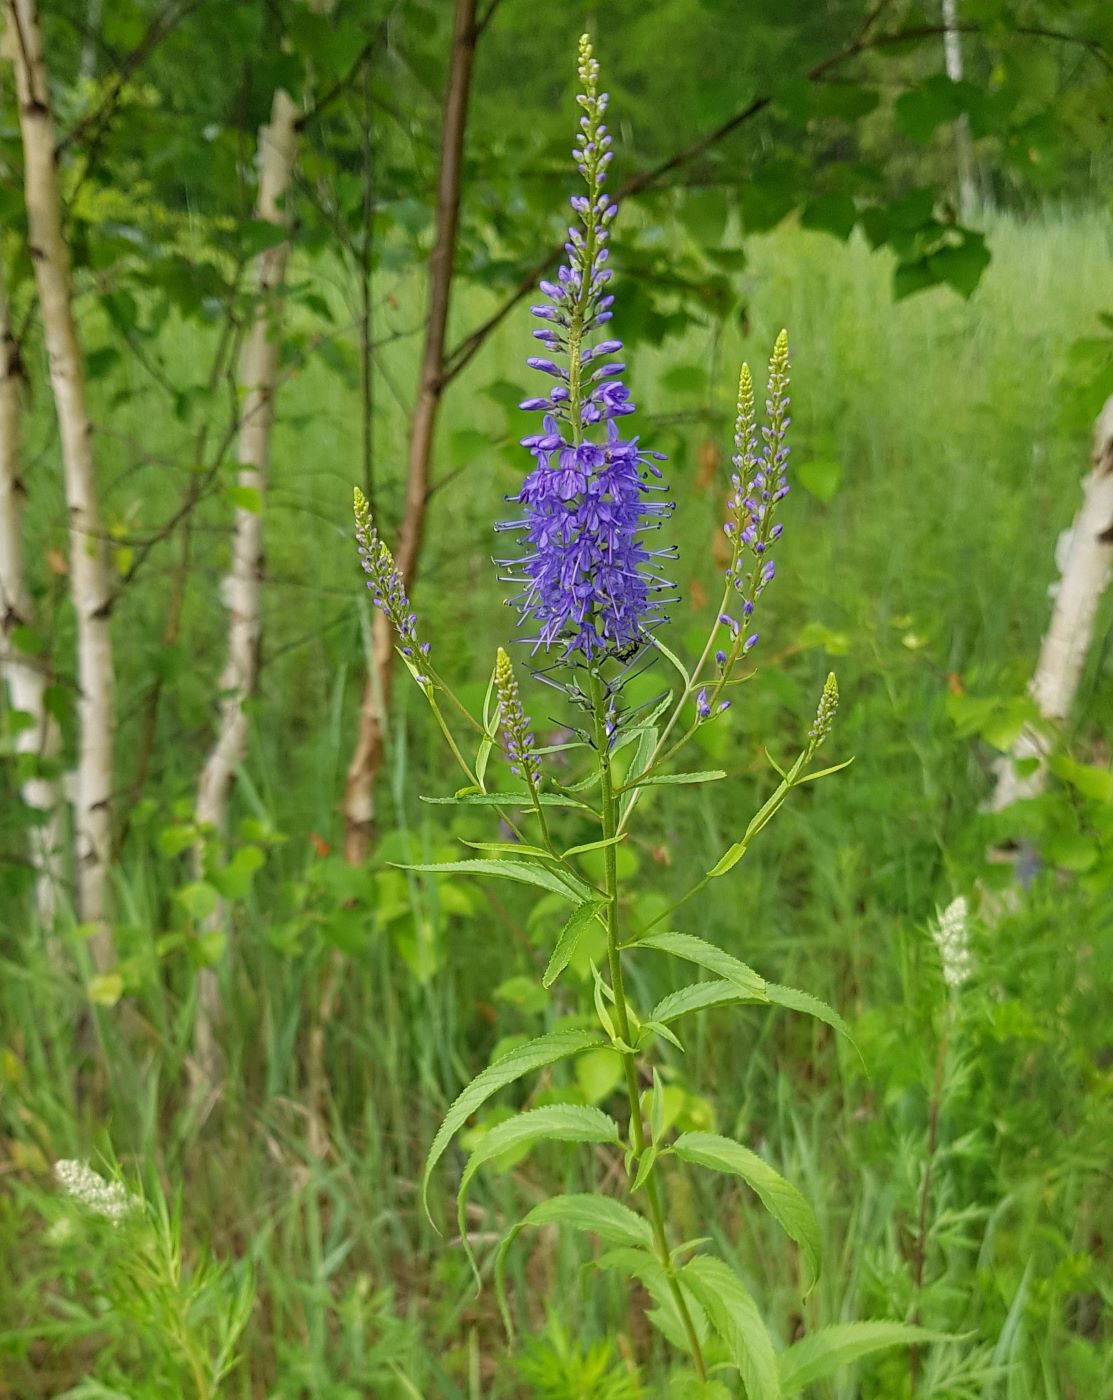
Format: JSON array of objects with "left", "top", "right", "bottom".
[{"left": 0, "top": 259, "right": 62, "bottom": 928}]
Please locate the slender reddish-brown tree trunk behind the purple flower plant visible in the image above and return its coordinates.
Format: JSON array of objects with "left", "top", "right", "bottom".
[{"left": 343, "top": 0, "right": 477, "bottom": 864}]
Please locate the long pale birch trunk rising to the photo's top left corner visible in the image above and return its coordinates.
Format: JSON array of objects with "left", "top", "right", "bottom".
[{"left": 7, "top": 0, "right": 116, "bottom": 967}]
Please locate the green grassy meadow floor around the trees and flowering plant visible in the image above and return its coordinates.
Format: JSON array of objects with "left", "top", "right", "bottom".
[{"left": 0, "top": 214, "right": 1113, "bottom": 1400}]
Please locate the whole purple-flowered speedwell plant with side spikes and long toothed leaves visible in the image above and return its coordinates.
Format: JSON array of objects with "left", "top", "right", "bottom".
[{"left": 356, "top": 30, "right": 940, "bottom": 1400}]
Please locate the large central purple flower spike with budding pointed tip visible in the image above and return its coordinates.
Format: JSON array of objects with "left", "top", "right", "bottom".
[{"left": 497, "top": 38, "right": 675, "bottom": 664}]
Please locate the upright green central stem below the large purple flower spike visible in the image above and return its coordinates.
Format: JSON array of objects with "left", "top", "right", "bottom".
[{"left": 591, "top": 672, "right": 707, "bottom": 1380}]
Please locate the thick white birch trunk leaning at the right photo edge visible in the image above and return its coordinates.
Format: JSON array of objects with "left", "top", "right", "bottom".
[{"left": 990, "top": 398, "right": 1113, "bottom": 811}]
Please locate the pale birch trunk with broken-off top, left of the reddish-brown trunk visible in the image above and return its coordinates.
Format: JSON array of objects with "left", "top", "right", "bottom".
[{"left": 196, "top": 90, "right": 298, "bottom": 1078}]
